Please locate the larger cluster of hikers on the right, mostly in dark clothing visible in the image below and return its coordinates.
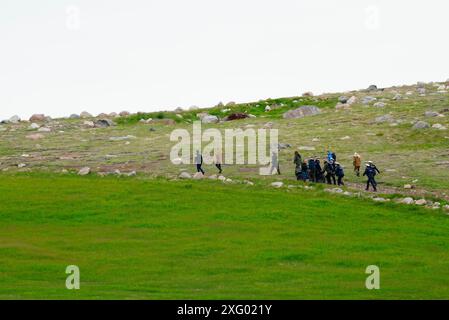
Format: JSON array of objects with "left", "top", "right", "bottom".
[{"left": 293, "top": 151, "right": 380, "bottom": 191}]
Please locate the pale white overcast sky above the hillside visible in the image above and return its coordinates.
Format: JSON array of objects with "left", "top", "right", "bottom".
[{"left": 0, "top": 0, "right": 449, "bottom": 119}]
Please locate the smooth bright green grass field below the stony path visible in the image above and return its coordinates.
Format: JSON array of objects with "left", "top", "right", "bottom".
[{"left": 0, "top": 174, "right": 449, "bottom": 299}]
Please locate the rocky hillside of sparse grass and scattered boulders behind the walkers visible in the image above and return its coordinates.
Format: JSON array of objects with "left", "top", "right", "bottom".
[{"left": 0, "top": 82, "right": 449, "bottom": 208}]
